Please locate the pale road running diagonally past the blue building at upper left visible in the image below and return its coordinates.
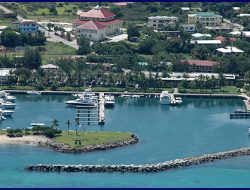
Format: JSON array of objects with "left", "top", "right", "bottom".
[{"left": 0, "top": 5, "right": 79, "bottom": 49}]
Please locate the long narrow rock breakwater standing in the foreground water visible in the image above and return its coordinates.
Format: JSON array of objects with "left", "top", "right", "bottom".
[{"left": 25, "top": 148, "right": 250, "bottom": 173}]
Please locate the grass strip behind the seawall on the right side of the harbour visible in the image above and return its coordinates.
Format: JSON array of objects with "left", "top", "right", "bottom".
[{"left": 180, "top": 86, "right": 239, "bottom": 94}]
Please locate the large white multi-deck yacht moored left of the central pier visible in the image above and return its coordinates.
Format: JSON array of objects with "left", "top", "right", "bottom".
[{"left": 65, "top": 89, "right": 98, "bottom": 106}]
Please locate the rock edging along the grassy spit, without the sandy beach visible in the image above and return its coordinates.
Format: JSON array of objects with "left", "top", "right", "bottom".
[{"left": 38, "top": 134, "right": 139, "bottom": 153}]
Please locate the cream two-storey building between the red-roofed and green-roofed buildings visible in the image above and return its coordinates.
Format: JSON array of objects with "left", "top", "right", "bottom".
[{"left": 148, "top": 16, "right": 179, "bottom": 29}]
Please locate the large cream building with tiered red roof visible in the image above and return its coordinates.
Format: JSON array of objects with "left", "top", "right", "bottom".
[{"left": 73, "top": 5, "right": 122, "bottom": 41}]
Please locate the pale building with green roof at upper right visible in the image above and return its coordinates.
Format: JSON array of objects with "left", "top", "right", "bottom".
[{"left": 188, "top": 12, "right": 223, "bottom": 27}]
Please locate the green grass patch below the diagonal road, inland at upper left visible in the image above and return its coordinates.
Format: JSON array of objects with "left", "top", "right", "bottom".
[{"left": 38, "top": 41, "right": 76, "bottom": 64}]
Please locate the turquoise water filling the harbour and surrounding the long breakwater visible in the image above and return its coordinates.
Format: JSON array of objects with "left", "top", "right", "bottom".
[{"left": 0, "top": 95, "right": 250, "bottom": 187}]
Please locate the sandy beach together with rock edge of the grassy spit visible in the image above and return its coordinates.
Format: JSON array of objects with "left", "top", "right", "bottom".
[{"left": 0, "top": 134, "right": 139, "bottom": 153}]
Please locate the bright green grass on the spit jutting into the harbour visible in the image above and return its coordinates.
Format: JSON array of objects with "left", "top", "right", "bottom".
[{"left": 55, "top": 131, "right": 132, "bottom": 147}]
